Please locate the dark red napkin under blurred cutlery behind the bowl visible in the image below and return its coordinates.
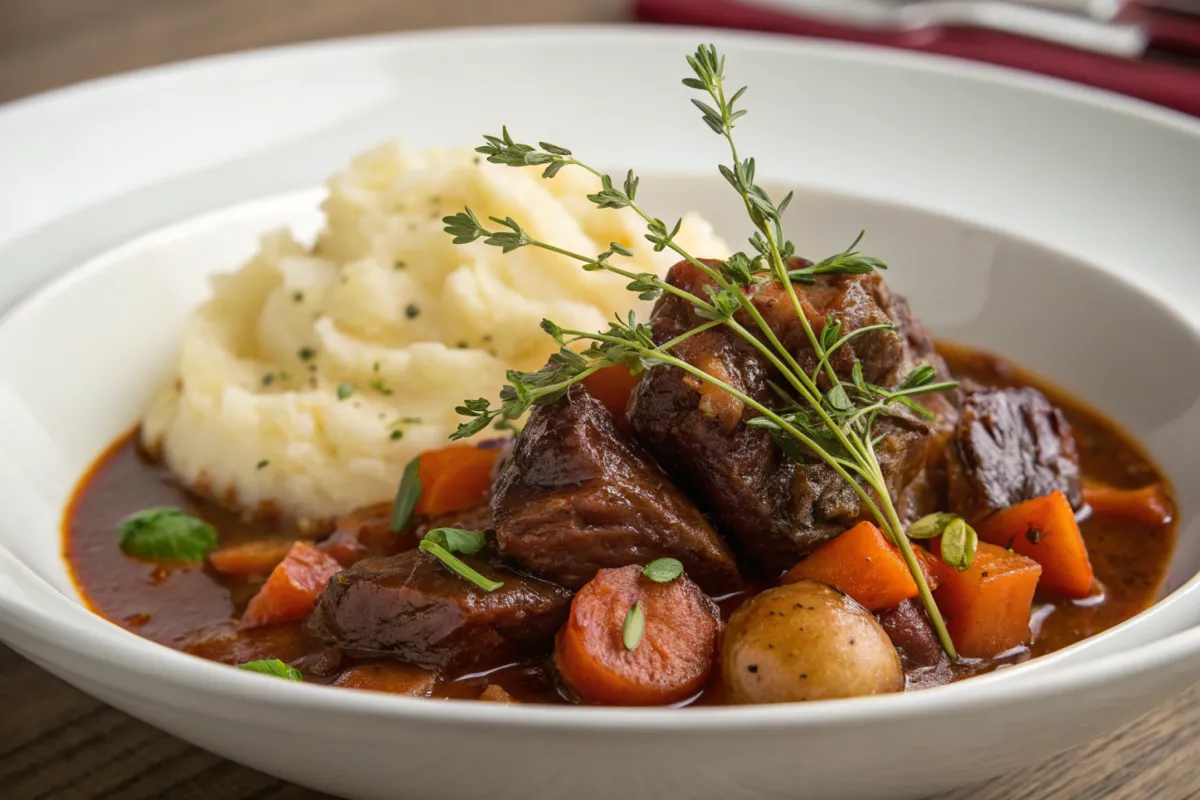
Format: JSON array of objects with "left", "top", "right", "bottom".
[{"left": 635, "top": 0, "right": 1200, "bottom": 116}]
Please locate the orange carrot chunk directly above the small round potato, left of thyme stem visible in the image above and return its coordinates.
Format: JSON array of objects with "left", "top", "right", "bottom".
[{"left": 782, "top": 522, "right": 919, "bottom": 612}]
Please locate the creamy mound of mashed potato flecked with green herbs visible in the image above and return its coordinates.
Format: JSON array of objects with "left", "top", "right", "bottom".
[{"left": 142, "top": 143, "right": 728, "bottom": 521}]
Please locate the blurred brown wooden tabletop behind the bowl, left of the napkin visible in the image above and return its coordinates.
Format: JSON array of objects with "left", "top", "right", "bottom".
[{"left": 0, "top": 0, "right": 631, "bottom": 102}]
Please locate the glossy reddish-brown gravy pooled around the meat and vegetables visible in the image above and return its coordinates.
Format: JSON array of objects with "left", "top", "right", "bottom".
[{"left": 64, "top": 344, "right": 1174, "bottom": 703}]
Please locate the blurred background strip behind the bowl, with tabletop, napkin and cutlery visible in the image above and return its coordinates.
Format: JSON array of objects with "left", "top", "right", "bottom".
[{"left": 0, "top": 0, "right": 1200, "bottom": 115}]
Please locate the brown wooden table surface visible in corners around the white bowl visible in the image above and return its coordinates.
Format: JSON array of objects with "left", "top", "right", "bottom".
[{"left": 0, "top": 0, "right": 1200, "bottom": 800}]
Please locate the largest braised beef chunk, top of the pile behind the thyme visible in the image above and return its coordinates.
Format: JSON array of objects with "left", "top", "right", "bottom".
[{"left": 629, "top": 263, "right": 944, "bottom": 573}]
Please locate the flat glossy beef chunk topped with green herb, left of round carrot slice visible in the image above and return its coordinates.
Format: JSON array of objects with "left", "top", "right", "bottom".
[{"left": 310, "top": 551, "right": 571, "bottom": 674}]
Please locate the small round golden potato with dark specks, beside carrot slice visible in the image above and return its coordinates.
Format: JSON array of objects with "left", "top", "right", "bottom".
[{"left": 721, "top": 581, "right": 905, "bottom": 703}]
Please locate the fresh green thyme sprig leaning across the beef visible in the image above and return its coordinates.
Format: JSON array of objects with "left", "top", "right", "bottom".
[{"left": 444, "top": 46, "right": 956, "bottom": 657}]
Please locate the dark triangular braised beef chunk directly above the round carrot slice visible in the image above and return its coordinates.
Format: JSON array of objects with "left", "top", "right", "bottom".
[{"left": 492, "top": 385, "right": 742, "bottom": 595}]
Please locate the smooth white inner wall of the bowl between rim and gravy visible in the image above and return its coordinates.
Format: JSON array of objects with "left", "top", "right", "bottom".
[{"left": 0, "top": 175, "right": 1200, "bottom": 654}]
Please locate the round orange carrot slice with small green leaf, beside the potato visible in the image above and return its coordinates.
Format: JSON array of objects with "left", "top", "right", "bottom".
[{"left": 554, "top": 564, "right": 720, "bottom": 705}]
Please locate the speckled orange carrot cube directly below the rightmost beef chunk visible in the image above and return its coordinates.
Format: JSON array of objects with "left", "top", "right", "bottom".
[{"left": 977, "top": 492, "right": 1096, "bottom": 597}]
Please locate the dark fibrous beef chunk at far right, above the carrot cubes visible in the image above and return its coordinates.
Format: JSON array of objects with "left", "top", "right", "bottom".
[{"left": 948, "top": 389, "right": 1082, "bottom": 521}]
